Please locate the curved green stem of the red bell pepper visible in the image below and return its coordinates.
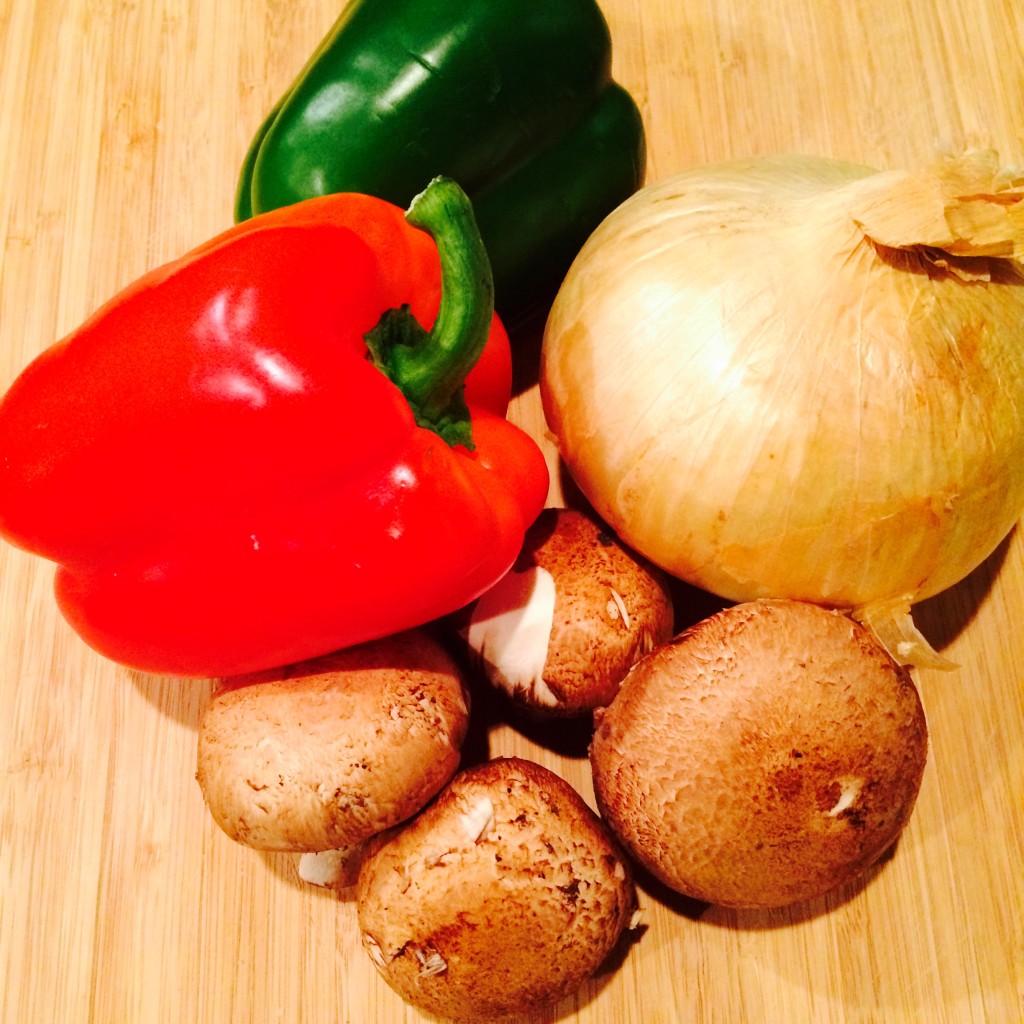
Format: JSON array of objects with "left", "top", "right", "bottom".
[{"left": 367, "top": 177, "right": 495, "bottom": 446}]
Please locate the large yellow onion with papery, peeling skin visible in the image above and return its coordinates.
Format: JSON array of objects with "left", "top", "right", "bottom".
[{"left": 541, "top": 152, "right": 1024, "bottom": 664}]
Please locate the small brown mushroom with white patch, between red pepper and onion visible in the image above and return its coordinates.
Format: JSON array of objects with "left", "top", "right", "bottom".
[{"left": 463, "top": 508, "right": 673, "bottom": 716}]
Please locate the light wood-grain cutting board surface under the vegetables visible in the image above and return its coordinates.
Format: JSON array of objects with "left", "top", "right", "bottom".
[{"left": 0, "top": 0, "right": 1024, "bottom": 1024}]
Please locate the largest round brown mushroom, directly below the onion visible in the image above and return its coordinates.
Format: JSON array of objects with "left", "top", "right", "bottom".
[{"left": 591, "top": 600, "right": 928, "bottom": 907}]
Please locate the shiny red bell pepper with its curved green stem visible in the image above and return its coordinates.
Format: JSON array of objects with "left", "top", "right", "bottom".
[{"left": 0, "top": 179, "right": 548, "bottom": 677}]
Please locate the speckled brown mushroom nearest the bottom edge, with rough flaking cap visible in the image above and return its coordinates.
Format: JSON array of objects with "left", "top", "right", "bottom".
[{"left": 357, "top": 758, "right": 636, "bottom": 1021}]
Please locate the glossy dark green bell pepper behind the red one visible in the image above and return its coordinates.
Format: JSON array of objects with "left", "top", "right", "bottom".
[{"left": 234, "top": 0, "right": 646, "bottom": 322}]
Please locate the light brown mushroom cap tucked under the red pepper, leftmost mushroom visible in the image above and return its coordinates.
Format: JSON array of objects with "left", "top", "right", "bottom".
[{"left": 197, "top": 630, "right": 469, "bottom": 851}]
